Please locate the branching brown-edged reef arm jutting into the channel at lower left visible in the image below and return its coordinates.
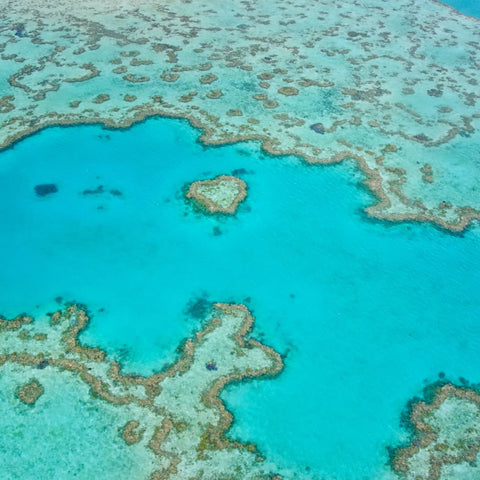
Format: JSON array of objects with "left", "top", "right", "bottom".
[{"left": 0, "top": 303, "right": 282, "bottom": 480}]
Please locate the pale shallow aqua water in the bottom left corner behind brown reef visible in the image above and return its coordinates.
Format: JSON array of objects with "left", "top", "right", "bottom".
[{"left": 0, "top": 367, "right": 157, "bottom": 480}]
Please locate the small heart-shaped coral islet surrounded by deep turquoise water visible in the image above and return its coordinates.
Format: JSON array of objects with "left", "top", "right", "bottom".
[{"left": 186, "top": 175, "right": 247, "bottom": 215}]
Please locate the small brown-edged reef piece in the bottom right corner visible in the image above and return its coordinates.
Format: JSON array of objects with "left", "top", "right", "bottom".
[{"left": 392, "top": 384, "right": 480, "bottom": 480}]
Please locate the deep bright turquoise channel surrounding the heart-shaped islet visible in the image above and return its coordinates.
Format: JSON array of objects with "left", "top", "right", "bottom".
[{"left": 0, "top": 119, "right": 480, "bottom": 480}]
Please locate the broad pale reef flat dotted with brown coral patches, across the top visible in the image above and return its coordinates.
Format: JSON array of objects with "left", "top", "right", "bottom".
[{"left": 0, "top": 0, "right": 480, "bottom": 231}]
